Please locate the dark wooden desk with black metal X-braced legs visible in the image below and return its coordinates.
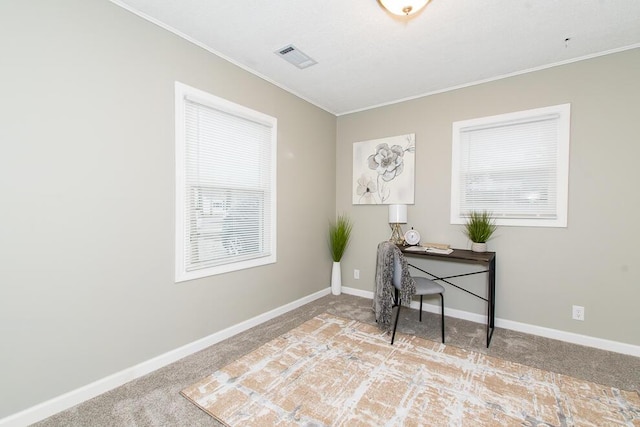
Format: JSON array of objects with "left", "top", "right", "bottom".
[{"left": 400, "top": 246, "right": 496, "bottom": 348}]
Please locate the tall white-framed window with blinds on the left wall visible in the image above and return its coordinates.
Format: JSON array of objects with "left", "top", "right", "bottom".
[{"left": 175, "top": 82, "right": 277, "bottom": 282}]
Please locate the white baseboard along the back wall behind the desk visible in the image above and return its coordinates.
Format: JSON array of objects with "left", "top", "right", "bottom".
[{"left": 342, "top": 286, "right": 640, "bottom": 357}]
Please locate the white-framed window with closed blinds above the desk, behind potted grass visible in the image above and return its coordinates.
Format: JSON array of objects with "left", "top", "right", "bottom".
[{"left": 451, "top": 104, "right": 570, "bottom": 227}]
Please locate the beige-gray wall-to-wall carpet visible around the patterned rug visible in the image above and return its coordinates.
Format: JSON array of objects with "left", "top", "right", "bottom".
[{"left": 35, "top": 294, "right": 640, "bottom": 427}]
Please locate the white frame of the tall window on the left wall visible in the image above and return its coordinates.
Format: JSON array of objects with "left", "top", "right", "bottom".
[{"left": 175, "top": 82, "right": 277, "bottom": 282}]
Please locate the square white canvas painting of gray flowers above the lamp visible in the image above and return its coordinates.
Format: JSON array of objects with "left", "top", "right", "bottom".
[{"left": 353, "top": 133, "right": 416, "bottom": 205}]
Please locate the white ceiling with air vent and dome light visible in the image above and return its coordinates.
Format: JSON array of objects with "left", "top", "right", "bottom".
[{"left": 112, "top": 0, "right": 640, "bottom": 115}]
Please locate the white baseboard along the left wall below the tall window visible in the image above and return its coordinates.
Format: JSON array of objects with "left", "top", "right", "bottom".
[{"left": 0, "top": 288, "right": 331, "bottom": 427}]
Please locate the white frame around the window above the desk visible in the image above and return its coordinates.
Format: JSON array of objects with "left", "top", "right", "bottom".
[{"left": 451, "top": 104, "right": 571, "bottom": 227}]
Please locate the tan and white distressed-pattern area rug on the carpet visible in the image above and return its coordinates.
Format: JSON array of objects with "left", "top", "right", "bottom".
[{"left": 182, "top": 314, "right": 640, "bottom": 427}]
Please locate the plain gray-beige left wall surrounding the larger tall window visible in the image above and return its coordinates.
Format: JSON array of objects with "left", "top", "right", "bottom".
[{"left": 0, "top": 0, "right": 336, "bottom": 418}]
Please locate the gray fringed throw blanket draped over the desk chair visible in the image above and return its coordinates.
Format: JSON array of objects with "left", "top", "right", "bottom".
[{"left": 373, "top": 242, "right": 416, "bottom": 332}]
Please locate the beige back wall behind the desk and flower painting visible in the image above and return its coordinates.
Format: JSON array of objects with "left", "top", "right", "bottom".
[{"left": 337, "top": 49, "right": 640, "bottom": 345}]
